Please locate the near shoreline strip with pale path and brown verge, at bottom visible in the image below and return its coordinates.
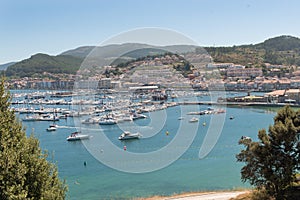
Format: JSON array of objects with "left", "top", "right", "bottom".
[{"left": 134, "top": 188, "right": 252, "bottom": 200}]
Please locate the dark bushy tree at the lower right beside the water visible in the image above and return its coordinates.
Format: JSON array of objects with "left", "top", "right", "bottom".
[{"left": 237, "top": 106, "right": 300, "bottom": 199}]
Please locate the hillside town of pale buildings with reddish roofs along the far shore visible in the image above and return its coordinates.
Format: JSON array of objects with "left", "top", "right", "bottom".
[{"left": 8, "top": 58, "right": 300, "bottom": 92}]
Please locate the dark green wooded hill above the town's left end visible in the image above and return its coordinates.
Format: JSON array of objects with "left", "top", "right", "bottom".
[{"left": 6, "top": 54, "right": 82, "bottom": 77}]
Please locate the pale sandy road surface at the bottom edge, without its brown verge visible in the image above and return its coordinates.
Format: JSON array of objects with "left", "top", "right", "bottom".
[{"left": 164, "top": 191, "right": 247, "bottom": 200}]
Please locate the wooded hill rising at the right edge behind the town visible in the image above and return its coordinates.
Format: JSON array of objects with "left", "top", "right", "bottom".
[{"left": 205, "top": 36, "right": 300, "bottom": 67}]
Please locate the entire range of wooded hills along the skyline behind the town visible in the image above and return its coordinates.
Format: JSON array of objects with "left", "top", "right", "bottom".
[{"left": 6, "top": 36, "right": 300, "bottom": 77}]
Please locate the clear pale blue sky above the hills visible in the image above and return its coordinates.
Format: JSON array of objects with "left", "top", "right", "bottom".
[{"left": 0, "top": 0, "right": 300, "bottom": 64}]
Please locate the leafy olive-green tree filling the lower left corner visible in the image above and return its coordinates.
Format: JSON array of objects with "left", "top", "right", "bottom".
[{"left": 0, "top": 79, "right": 67, "bottom": 200}]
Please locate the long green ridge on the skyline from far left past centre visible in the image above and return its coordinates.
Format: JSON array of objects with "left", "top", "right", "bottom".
[{"left": 6, "top": 43, "right": 196, "bottom": 77}]
